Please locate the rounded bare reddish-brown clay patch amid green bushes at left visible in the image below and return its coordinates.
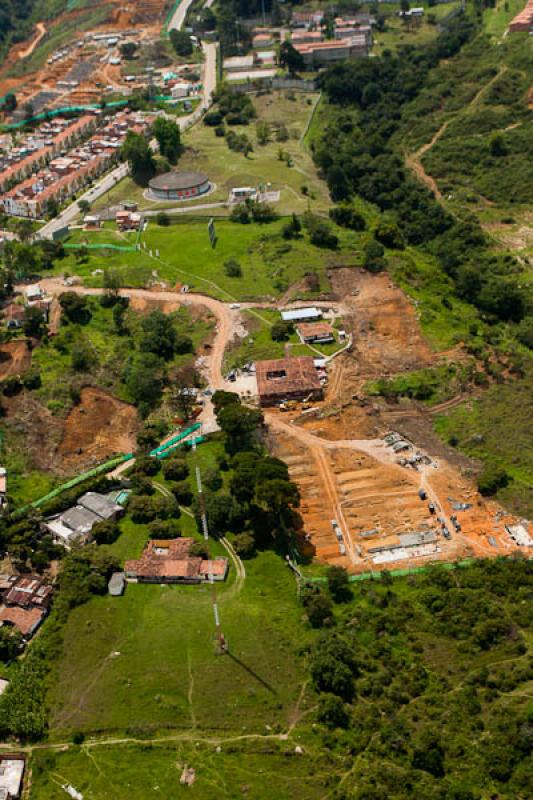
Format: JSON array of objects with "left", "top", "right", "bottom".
[{"left": 58, "top": 387, "right": 139, "bottom": 471}]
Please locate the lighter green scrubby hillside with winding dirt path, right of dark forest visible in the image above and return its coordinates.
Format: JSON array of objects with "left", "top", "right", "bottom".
[{"left": 402, "top": 35, "right": 533, "bottom": 206}]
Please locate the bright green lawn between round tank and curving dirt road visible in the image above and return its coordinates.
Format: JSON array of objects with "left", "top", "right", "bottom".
[{"left": 56, "top": 219, "right": 361, "bottom": 300}]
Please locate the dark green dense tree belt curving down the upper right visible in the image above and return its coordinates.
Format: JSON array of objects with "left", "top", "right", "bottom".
[{"left": 314, "top": 16, "right": 531, "bottom": 332}]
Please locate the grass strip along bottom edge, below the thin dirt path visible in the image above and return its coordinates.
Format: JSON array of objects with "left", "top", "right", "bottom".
[{"left": 31, "top": 732, "right": 334, "bottom": 800}]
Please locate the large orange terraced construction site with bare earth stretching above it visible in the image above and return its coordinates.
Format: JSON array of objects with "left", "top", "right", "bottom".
[{"left": 265, "top": 270, "right": 533, "bottom": 573}]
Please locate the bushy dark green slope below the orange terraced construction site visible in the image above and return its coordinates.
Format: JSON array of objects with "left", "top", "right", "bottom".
[{"left": 309, "top": 559, "right": 533, "bottom": 800}]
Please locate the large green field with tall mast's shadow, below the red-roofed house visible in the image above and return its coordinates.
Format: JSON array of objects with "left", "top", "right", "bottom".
[{"left": 44, "top": 552, "right": 308, "bottom": 740}]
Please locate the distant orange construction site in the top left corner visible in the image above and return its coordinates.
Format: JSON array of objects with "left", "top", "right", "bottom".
[{"left": 0, "top": 0, "right": 181, "bottom": 117}]
